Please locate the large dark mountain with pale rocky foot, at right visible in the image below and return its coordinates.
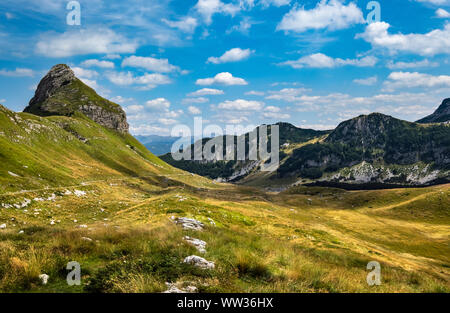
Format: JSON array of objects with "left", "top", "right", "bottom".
[{"left": 278, "top": 113, "right": 450, "bottom": 185}]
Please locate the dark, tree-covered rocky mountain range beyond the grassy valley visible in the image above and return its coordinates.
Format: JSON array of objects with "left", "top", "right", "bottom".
[{"left": 162, "top": 99, "right": 450, "bottom": 188}]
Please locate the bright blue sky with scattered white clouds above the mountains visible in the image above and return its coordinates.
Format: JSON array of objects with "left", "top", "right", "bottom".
[{"left": 0, "top": 0, "right": 450, "bottom": 135}]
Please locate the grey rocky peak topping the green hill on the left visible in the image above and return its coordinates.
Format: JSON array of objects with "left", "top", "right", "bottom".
[{"left": 24, "top": 64, "right": 129, "bottom": 133}]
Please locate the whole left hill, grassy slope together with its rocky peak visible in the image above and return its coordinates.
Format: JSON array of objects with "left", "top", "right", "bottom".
[{"left": 0, "top": 65, "right": 213, "bottom": 193}]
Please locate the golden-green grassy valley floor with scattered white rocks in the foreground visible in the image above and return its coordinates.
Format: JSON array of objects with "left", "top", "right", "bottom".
[{"left": 0, "top": 175, "right": 450, "bottom": 292}]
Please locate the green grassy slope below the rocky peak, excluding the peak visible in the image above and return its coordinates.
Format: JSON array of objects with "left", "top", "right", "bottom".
[{"left": 0, "top": 106, "right": 211, "bottom": 193}]
